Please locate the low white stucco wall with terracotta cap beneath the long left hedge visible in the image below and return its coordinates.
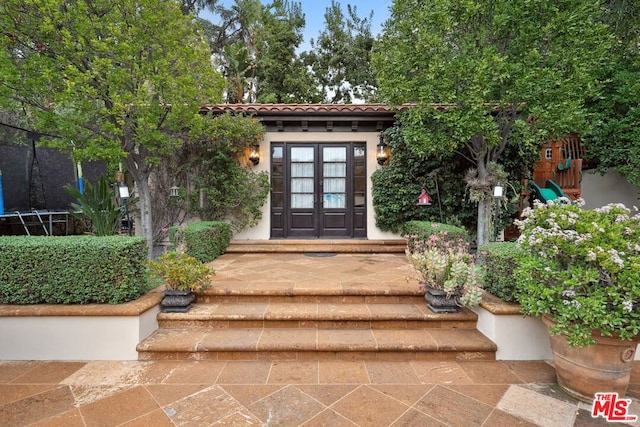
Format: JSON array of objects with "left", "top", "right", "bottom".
[{"left": 0, "top": 288, "right": 162, "bottom": 360}]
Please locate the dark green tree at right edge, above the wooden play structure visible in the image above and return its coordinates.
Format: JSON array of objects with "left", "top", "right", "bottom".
[{"left": 584, "top": 0, "right": 640, "bottom": 186}]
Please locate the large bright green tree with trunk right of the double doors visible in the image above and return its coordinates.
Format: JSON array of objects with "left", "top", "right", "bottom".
[{"left": 373, "top": 0, "right": 611, "bottom": 244}]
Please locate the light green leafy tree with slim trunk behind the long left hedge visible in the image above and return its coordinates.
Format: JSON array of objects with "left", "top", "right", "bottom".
[{"left": 0, "top": 0, "right": 224, "bottom": 254}]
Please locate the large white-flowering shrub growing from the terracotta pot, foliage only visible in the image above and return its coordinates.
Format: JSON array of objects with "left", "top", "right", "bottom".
[{"left": 514, "top": 199, "right": 640, "bottom": 346}]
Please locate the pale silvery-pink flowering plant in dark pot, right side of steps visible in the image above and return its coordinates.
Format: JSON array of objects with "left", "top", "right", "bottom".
[{"left": 406, "top": 233, "right": 482, "bottom": 313}]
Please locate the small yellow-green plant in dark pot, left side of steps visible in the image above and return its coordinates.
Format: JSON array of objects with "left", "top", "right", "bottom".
[{"left": 149, "top": 251, "right": 215, "bottom": 312}]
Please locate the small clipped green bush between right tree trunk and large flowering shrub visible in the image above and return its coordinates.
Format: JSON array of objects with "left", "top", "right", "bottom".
[{"left": 478, "top": 242, "right": 521, "bottom": 303}]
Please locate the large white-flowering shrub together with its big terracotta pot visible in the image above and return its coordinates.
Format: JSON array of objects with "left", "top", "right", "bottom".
[{"left": 514, "top": 199, "right": 640, "bottom": 401}]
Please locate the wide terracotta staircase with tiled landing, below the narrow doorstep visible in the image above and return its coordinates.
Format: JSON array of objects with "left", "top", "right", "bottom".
[{"left": 137, "top": 243, "right": 496, "bottom": 360}]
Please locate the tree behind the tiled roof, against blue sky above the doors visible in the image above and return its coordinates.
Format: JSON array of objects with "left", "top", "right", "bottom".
[{"left": 302, "top": 0, "right": 376, "bottom": 103}]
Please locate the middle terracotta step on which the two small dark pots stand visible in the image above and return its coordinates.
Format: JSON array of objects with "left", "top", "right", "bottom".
[{"left": 158, "top": 300, "right": 478, "bottom": 329}]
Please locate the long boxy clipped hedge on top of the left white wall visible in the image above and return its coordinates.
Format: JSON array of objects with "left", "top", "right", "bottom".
[{"left": 0, "top": 236, "right": 150, "bottom": 304}]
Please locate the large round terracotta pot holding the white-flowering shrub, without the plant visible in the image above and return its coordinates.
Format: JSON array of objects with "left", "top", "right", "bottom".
[{"left": 542, "top": 315, "right": 638, "bottom": 403}]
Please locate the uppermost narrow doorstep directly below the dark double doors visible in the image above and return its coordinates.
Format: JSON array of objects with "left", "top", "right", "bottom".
[{"left": 226, "top": 239, "right": 407, "bottom": 256}]
